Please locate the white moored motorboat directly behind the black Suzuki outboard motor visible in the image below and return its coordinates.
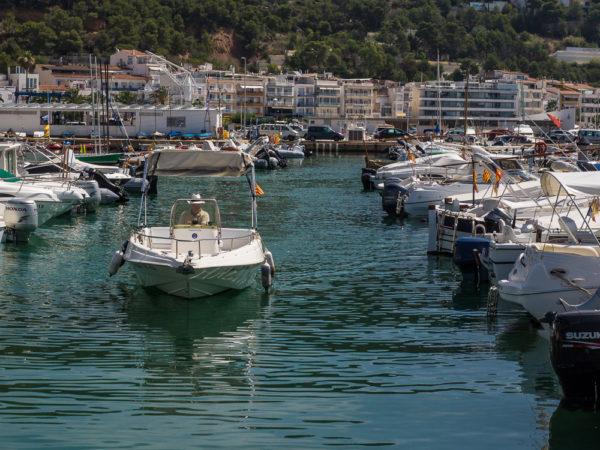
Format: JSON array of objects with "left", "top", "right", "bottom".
[{"left": 498, "top": 172, "right": 600, "bottom": 320}]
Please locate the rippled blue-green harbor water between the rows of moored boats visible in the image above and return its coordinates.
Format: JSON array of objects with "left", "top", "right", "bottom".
[{"left": 0, "top": 155, "right": 600, "bottom": 449}]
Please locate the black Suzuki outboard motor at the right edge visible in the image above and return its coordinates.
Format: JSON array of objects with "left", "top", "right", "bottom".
[{"left": 546, "top": 310, "right": 600, "bottom": 407}]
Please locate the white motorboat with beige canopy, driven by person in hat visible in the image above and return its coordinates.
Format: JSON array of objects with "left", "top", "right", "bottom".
[{"left": 109, "top": 149, "right": 274, "bottom": 298}]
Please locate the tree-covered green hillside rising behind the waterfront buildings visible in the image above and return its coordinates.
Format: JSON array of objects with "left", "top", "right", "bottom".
[{"left": 0, "top": 0, "right": 600, "bottom": 84}]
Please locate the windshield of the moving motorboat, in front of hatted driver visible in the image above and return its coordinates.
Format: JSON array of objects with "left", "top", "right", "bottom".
[{"left": 171, "top": 198, "right": 221, "bottom": 228}]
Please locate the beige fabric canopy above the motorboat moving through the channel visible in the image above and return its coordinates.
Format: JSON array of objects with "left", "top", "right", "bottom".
[{"left": 148, "top": 149, "right": 253, "bottom": 178}]
